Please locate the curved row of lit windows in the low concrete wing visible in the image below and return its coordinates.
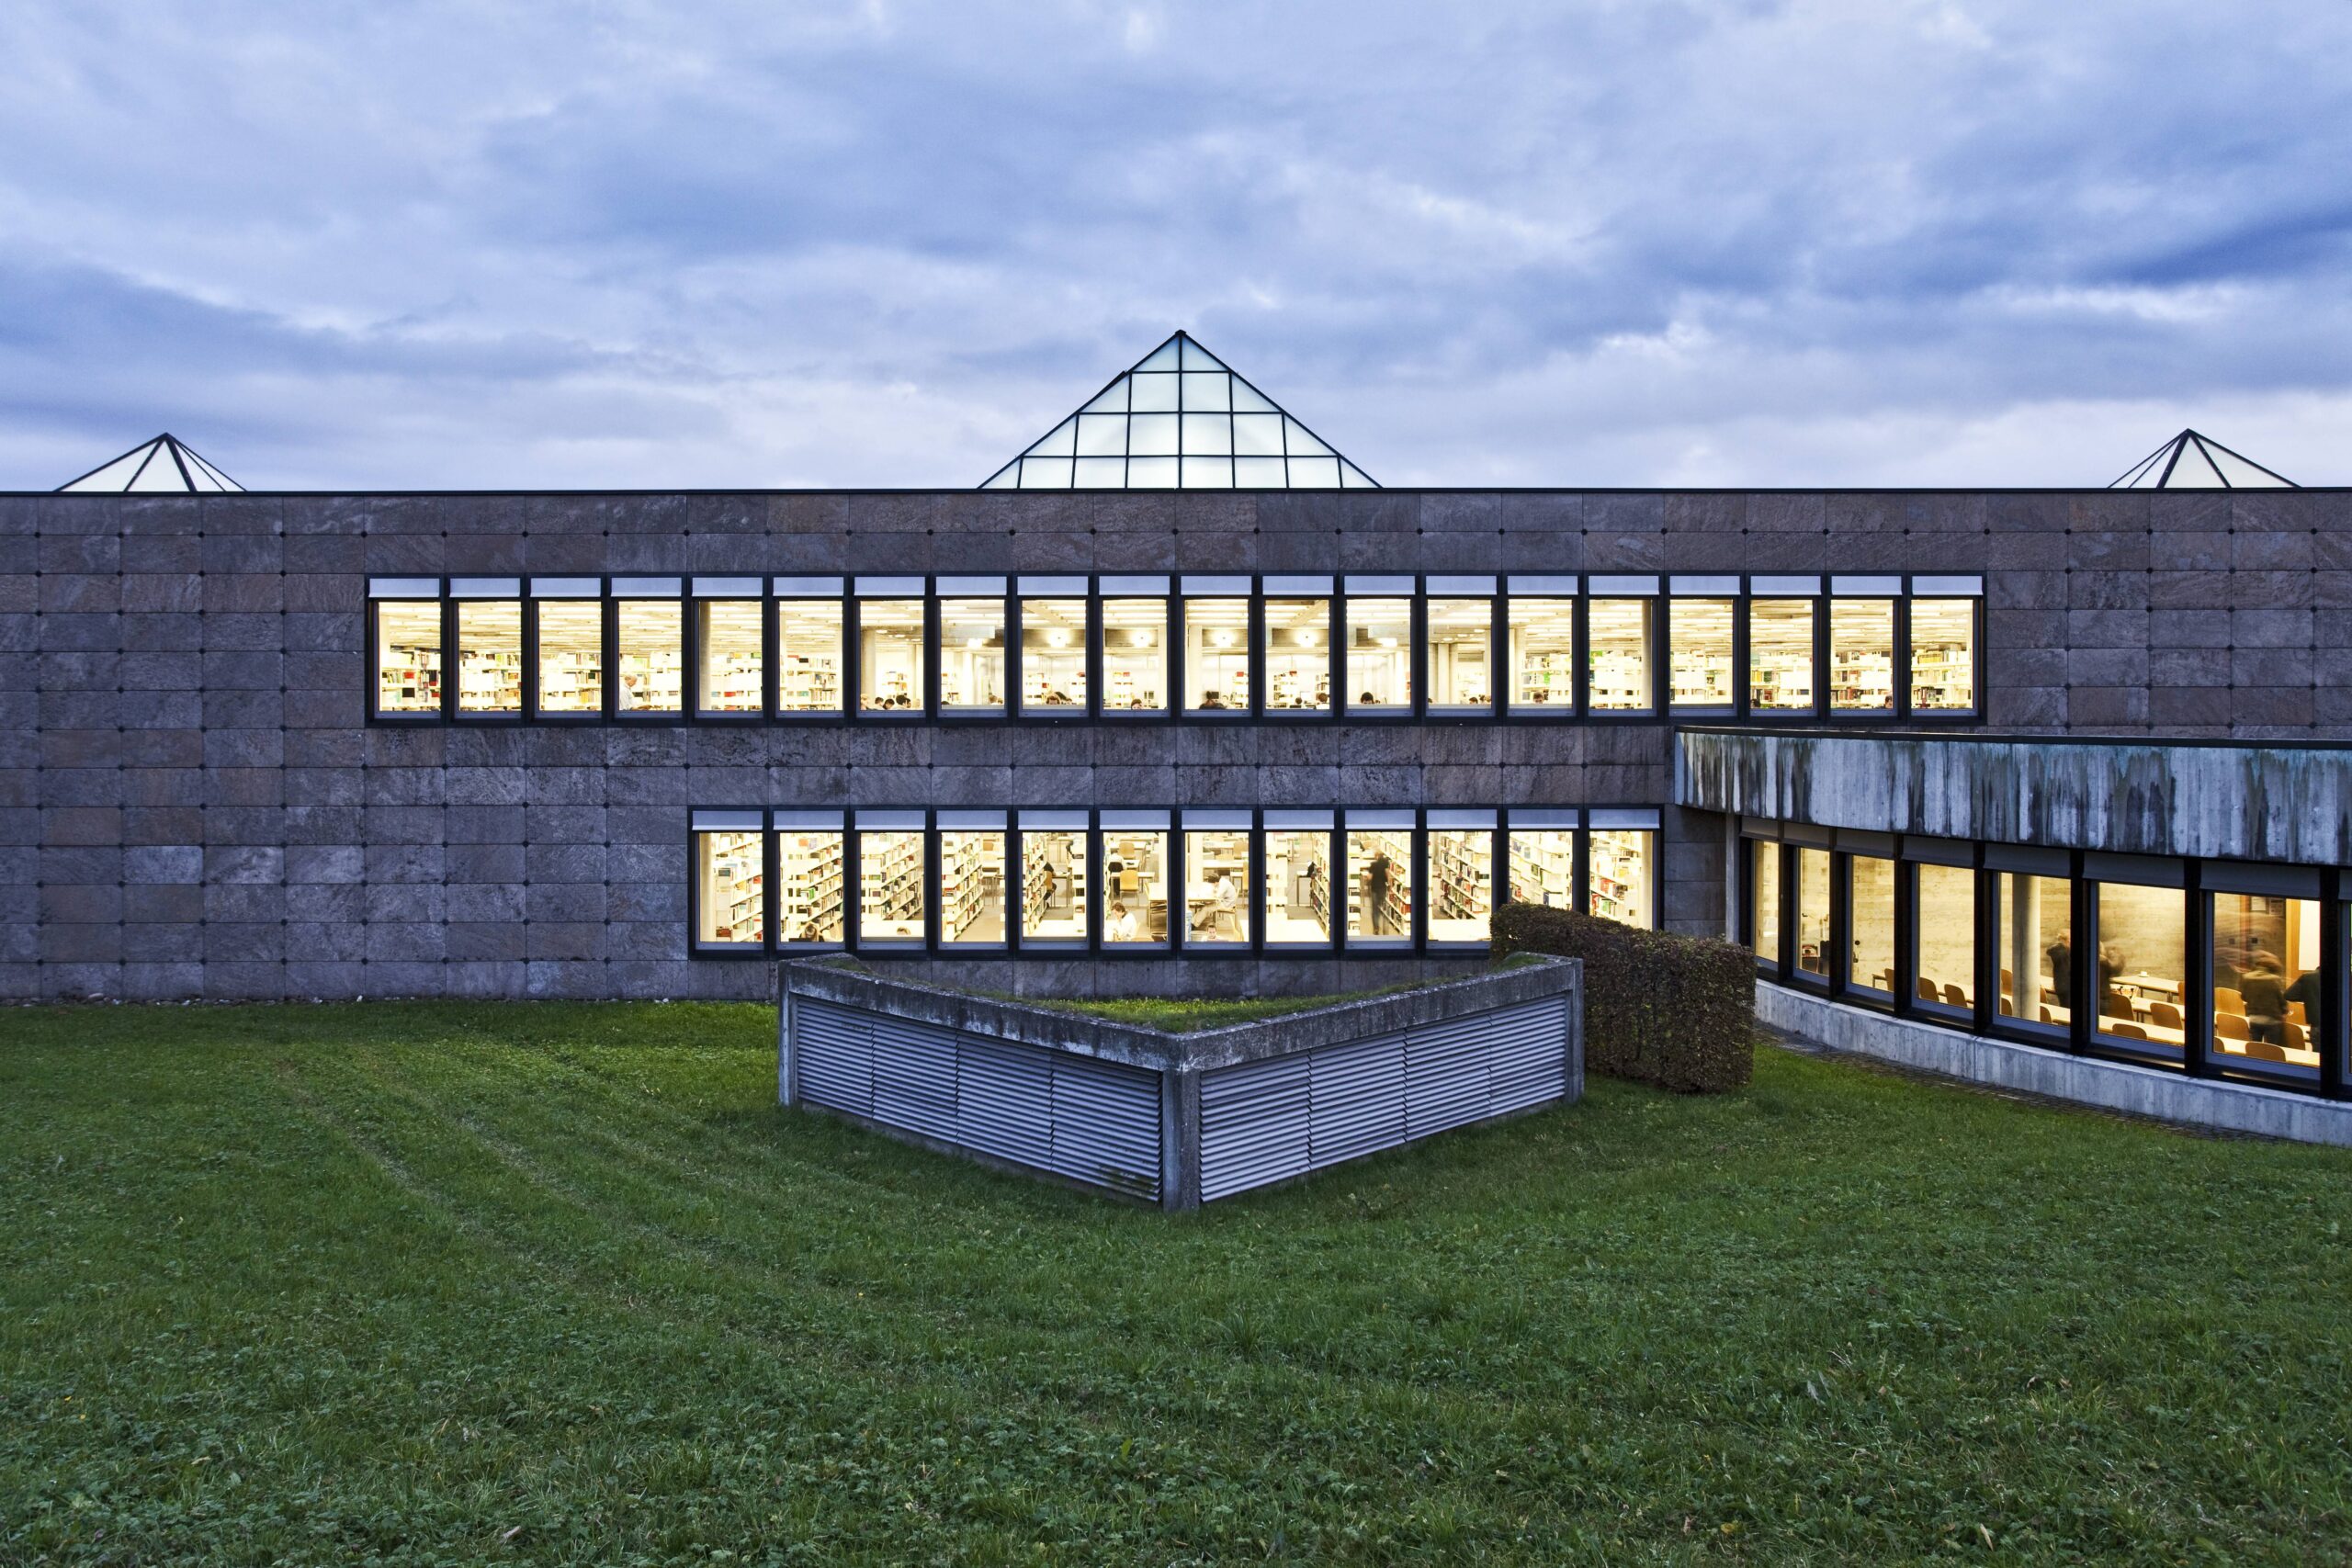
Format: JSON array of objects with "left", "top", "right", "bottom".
[{"left": 1740, "top": 823, "right": 2352, "bottom": 1098}]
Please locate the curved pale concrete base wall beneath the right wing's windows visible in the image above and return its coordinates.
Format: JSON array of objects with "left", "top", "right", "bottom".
[{"left": 1757, "top": 980, "right": 2352, "bottom": 1147}]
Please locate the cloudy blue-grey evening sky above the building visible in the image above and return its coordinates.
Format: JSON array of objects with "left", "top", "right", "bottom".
[{"left": 0, "top": 0, "right": 2352, "bottom": 489}]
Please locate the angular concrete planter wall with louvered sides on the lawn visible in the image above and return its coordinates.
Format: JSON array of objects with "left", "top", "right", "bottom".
[{"left": 776, "top": 959, "right": 1585, "bottom": 1208}]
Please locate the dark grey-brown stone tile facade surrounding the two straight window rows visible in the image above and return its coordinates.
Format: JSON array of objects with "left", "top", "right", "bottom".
[{"left": 0, "top": 491, "right": 2352, "bottom": 997}]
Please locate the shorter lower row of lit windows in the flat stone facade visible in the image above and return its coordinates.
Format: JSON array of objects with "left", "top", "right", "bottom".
[{"left": 689, "top": 808, "right": 1658, "bottom": 957}]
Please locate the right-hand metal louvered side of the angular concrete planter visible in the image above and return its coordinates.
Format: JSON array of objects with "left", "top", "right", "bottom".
[{"left": 1200, "top": 997, "right": 1571, "bottom": 1201}]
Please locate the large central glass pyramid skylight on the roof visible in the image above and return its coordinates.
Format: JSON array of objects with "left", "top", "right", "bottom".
[{"left": 981, "top": 332, "right": 1378, "bottom": 489}]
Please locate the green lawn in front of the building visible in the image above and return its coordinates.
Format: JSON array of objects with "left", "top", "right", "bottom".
[{"left": 0, "top": 1004, "right": 2352, "bottom": 1563}]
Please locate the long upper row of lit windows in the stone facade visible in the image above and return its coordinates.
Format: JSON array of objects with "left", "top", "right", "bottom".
[{"left": 369, "top": 573, "right": 1983, "bottom": 722}]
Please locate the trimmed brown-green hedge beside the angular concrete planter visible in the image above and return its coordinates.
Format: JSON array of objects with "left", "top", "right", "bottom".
[{"left": 1494, "top": 903, "right": 1757, "bottom": 1093}]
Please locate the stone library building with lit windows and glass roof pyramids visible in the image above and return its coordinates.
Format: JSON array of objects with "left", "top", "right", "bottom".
[{"left": 14, "top": 333, "right": 2352, "bottom": 1119}]
